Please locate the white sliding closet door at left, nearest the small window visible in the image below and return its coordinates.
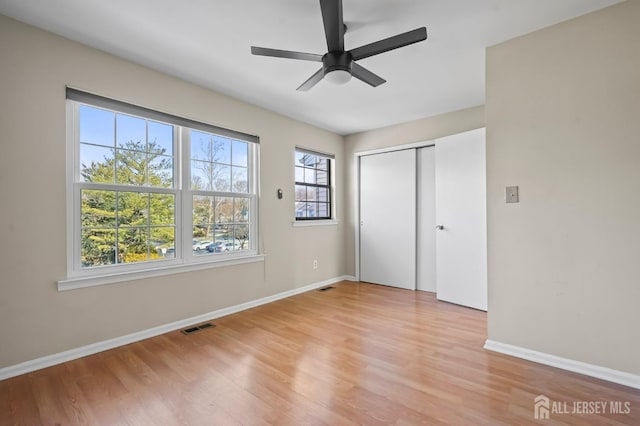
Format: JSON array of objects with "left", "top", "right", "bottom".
[{"left": 360, "top": 149, "right": 416, "bottom": 290}]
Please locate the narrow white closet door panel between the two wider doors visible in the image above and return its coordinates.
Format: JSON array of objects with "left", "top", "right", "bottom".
[{"left": 416, "top": 146, "right": 436, "bottom": 293}]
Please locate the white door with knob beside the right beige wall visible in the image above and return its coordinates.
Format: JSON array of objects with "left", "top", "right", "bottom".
[{"left": 435, "top": 129, "right": 487, "bottom": 311}]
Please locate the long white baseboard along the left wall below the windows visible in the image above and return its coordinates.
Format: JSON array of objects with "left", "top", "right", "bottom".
[{"left": 0, "top": 275, "right": 355, "bottom": 380}]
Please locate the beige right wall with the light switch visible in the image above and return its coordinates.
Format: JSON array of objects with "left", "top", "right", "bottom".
[{"left": 486, "top": 0, "right": 640, "bottom": 374}]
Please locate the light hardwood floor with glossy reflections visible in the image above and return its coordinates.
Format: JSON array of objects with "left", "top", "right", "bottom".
[{"left": 0, "top": 282, "right": 640, "bottom": 425}]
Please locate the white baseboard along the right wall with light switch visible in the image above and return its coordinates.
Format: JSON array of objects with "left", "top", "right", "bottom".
[{"left": 484, "top": 339, "right": 640, "bottom": 389}]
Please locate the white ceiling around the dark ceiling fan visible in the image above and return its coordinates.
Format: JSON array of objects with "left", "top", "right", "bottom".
[{"left": 0, "top": 0, "right": 620, "bottom": 134}]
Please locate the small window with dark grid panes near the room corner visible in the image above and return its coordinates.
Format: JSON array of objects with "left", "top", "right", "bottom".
[{"left": 295, "top": 148, "right": 333, "bottom": 220}]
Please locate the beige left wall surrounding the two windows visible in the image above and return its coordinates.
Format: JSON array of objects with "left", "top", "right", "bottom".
[{"left": 0, "top": 16, "right": 345, "bottom": 368}]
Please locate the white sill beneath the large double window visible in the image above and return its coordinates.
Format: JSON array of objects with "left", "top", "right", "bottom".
[{"left": 58, "top": 254, "right": 264, "bottom": 291}]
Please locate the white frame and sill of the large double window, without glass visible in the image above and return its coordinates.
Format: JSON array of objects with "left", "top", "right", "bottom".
[{"left": 58, "top": 88, "right": 264, "bottom": 290}]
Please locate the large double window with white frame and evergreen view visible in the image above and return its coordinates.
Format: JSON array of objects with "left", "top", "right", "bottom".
[{"left": 67, "top": 88, "right": 258, "bottom": 277}]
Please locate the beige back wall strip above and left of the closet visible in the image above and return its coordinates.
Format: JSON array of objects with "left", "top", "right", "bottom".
[{"left": 344, "top": 106, "right": 484, "bottom": 275}]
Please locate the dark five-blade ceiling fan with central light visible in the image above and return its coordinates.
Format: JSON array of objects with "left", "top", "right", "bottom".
[{"left": 251, "top": 0, "right": 427, "bottom": 91}]
